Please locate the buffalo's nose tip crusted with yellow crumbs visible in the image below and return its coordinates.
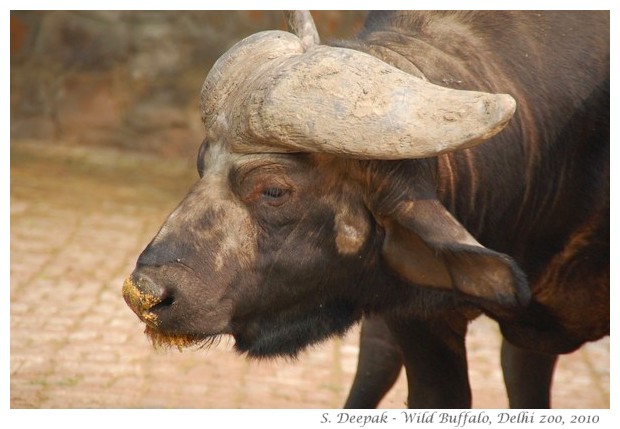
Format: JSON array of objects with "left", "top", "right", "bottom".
[{"left": 123, "top": 274, "right": 169, "bottom": 327}]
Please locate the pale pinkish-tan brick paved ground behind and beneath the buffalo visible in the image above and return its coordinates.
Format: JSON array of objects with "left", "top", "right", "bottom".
[{"left": 10, "top": 142, "right": 610, "bottom": 408}]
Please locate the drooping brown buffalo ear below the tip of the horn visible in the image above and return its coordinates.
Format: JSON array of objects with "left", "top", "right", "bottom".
[{"left": 382, "top": 199, "right": 530, "bottom": 316}]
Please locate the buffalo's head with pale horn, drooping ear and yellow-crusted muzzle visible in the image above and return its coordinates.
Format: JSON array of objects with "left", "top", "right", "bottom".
[{"left": 123, "top": 13, "right": 529, "bottom": 356}]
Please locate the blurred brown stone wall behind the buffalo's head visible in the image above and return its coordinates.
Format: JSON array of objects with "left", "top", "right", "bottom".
[{"left": 11, "top": 11, "right": 365, "bottom": 156}]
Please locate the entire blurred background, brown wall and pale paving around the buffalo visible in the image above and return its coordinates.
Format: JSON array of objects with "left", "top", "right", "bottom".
[{"left": 10, "top": 11, "right": 609, "bottom": 408}]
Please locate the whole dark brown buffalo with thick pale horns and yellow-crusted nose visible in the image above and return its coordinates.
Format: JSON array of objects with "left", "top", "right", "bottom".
[{"left": 123, "top": 11, "right": 609, "bottom": 408}]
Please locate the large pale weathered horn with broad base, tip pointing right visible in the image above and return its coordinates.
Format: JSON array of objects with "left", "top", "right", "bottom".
[{"left": 203, "top": 32, "right": 516, "bottom": 159}]
